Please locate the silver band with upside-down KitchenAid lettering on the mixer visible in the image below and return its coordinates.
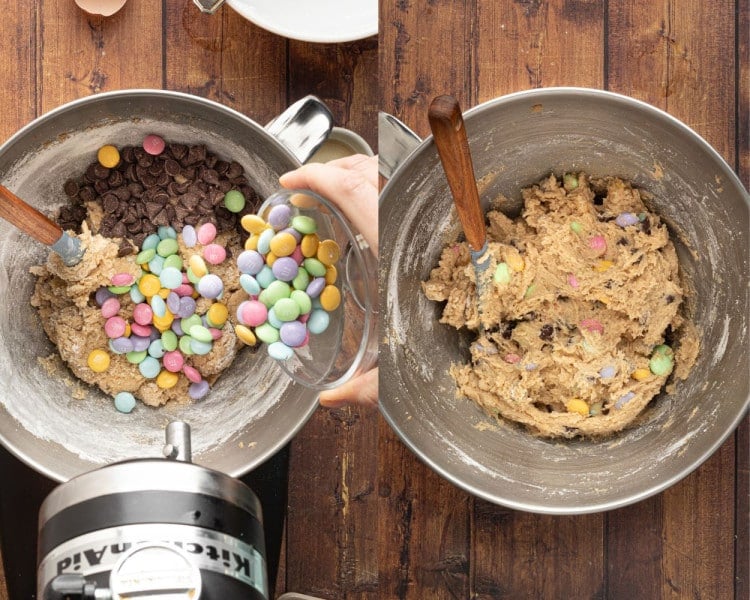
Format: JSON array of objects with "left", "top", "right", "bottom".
[{"left": 38, "top": 523, "right": 268, "bottom": 597}]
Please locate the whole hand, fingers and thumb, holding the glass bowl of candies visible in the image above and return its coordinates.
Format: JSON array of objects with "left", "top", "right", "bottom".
[{"left": 279, "top": 154, "right": 378, "bottom": 408}]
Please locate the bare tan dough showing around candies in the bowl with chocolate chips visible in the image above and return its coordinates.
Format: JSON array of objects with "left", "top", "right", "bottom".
[{"left": 31, "top": 225, "right": 247, "bottom": 406}]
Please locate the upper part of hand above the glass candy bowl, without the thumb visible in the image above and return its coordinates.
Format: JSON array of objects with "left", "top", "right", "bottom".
[{"left": 279, "top": 154, "right": 378, "bottom": 257}]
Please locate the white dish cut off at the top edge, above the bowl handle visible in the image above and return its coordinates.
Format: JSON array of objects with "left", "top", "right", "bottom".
[{"left": 227, "top": 0, "right": 378, "bottom": 43}]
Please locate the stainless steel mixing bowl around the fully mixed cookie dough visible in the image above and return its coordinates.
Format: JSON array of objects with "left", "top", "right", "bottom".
[{"left": 379, "top": 88, "right": 750, "bottom": 514}]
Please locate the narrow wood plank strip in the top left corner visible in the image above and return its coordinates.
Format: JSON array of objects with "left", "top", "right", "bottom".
[{"left": 0, "top": 0, "right": 38, "bottom": 141}]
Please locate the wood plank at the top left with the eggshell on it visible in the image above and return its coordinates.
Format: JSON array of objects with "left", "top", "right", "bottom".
[{"left": 38, "top": 0, "right": 162, "bottom": 112}]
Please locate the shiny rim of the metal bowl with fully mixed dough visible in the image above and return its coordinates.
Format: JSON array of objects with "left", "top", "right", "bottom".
[{"left": 379, "top": 87, "right": 750, "bottom": 515}]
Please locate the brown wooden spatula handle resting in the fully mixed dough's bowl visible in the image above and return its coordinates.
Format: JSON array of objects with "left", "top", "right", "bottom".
[{"left": 427, "top": 96, "right": 487, "bottom": 251}]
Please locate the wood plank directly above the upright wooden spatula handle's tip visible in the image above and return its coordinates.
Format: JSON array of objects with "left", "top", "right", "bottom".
[{"left": 380, "top": 0, "right": 475, "bottom": 137}]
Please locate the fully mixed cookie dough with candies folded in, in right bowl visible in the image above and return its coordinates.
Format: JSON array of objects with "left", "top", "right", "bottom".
[{"left": 423, "top": 173, "right": 699, "bottom": 438}]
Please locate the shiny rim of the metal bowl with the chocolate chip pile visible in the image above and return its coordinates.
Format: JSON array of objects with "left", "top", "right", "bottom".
[{"left": 0, "top": 88, "right": 318, "bottom": 483}]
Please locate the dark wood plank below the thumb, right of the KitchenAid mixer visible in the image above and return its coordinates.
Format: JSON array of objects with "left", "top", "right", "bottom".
[{"left": 285, "top": 407, "right": 378, "bottom": 600}]
